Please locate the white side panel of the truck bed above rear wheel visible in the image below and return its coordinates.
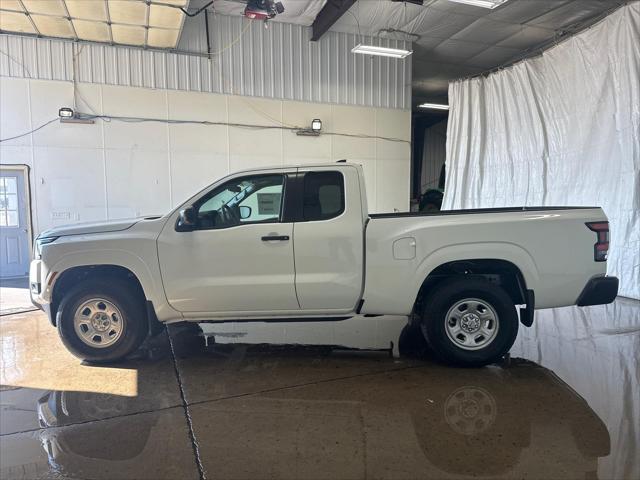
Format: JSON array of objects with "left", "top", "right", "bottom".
[{"left": 362, "top": 208, "right": 606, "bottom": 315}]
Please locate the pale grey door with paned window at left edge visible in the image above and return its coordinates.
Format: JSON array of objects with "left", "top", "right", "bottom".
[{"left": 0, "top": 169, "right": 31, "bottom": 278}]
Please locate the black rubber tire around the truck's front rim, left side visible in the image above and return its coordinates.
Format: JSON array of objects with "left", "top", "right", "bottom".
[{"left": 56, "top": 280, "right": 148, "bottom": 363}]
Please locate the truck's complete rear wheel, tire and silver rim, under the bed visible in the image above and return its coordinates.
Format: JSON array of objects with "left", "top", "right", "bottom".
[{"left": 421, "top": 278, "right": 518, "bottom": 367}]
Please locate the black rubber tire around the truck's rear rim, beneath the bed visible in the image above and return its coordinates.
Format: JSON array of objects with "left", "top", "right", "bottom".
[{"left": 420, "top": 278, "right": 518, "bottom": 367}]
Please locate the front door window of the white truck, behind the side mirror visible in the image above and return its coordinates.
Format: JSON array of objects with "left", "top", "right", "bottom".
[{"left": 194, "top": 175, "right": 284, "bottom": 230}]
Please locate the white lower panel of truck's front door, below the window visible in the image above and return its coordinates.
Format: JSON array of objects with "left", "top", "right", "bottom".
[{"left": 158, "top": 221, "right": 298, "bottom": 316}]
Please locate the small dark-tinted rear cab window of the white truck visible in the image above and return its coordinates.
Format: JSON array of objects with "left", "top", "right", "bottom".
[{"left": 302, "top": 172, "right": 344, "bottom": 222}]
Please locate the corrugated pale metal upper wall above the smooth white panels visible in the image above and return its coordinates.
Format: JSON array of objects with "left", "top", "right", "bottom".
[{"left": 0, "top": 15, "right": 411, "bottom": 109}]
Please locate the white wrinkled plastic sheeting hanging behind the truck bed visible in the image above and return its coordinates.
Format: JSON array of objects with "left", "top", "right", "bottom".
[{"left": 443, "top": 2, "right": 640, "bottom": 298}]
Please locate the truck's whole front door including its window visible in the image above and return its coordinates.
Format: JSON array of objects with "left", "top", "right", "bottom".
[{"left": 158, "top": 170, "right": 299, "bottom": 317}]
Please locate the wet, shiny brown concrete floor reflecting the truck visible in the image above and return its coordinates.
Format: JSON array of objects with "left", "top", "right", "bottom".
[{"left": 0, "top": 299, "right": 640, "bottom": 479}]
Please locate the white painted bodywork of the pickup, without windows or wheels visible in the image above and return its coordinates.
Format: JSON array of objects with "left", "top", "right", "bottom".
[{"left": 31, "top": 163, "right": 606, "bottom": 322}]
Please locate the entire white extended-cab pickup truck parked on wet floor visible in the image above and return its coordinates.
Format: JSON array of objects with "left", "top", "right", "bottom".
[{"left": 30, "top": 163, "right": 618, "bottom": 366}]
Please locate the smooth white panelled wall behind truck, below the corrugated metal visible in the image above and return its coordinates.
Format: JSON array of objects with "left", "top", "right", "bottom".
[{"left": 0, "top": 77, "right": 411, "bottom": 232}]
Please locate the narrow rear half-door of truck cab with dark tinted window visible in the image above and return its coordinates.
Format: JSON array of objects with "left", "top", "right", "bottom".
[{"left": 293, "top": 165, "right": 364, "bottom": 313}]
